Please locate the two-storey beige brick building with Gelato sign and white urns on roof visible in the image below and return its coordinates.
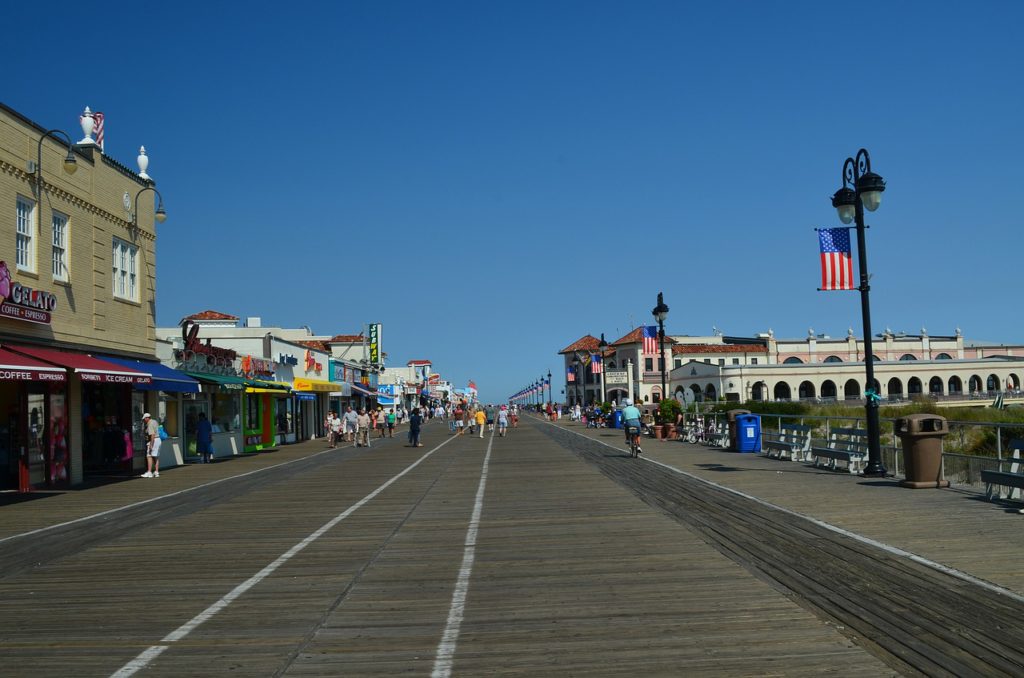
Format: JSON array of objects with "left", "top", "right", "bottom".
[{"left": 0, "top": 104, "right": 163, "bottom": 490}]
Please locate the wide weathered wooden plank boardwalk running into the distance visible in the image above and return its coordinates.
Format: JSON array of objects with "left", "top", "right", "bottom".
[{"left": 0, "top": 413, "right": 1021, "bottom": 676}]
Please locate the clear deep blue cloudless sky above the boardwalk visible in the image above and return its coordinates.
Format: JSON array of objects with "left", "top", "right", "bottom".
[{"left": 0, "top": 1, "right": 1024, "bottom": 400}]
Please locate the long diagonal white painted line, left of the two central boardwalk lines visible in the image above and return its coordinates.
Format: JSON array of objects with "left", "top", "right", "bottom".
[{"left": 112, "top": 438, "right": 455, "bottom": 678}]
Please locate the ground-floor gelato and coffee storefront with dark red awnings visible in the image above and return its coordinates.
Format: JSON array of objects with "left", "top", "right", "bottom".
[{"left": 4, "top": 344, "right": 153, "bottom": 486}]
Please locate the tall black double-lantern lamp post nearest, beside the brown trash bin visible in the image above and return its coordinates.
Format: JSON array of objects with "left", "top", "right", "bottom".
[{"left": 833, "top": 149, "right": 886, "bottom": 477}]
